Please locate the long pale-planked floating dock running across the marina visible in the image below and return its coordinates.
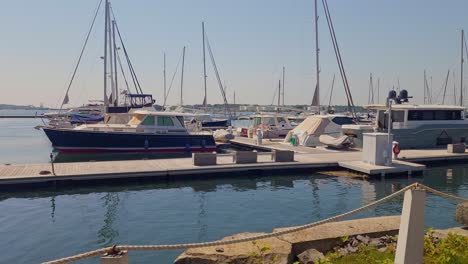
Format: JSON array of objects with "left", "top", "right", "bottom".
[{"left": 0, "top": 146, "right": 468, "bottom": 186}]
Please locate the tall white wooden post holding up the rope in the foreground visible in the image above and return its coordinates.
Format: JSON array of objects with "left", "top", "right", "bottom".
[{"left": 395, "top": 189, "right": 426, "bottom": 264}]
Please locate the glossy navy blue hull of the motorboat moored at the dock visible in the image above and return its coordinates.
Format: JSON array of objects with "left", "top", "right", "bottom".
[{"left": 43, "top": 128, "right": 216, "bottom": 153}]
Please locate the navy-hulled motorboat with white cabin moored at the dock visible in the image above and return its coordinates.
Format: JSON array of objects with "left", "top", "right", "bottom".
[{"left": 43, "top": 111, "right": 216, "bottom": 152}]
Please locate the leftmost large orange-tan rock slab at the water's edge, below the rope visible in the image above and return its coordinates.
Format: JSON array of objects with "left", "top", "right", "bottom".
[{"left": 174, "top": 233, "right": 293, "bottom": 264}]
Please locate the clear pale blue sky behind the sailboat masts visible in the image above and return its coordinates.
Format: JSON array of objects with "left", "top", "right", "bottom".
[{"left": 0, "top": 0, "right": 468, "bottom": 106}]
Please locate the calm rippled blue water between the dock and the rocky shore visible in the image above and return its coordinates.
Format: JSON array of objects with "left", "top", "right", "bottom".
[{"left": 0, "top": 166, "right": 468, "bottom": 263}]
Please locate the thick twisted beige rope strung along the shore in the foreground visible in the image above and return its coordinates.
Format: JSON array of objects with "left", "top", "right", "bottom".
[{"left": 44, "top": 183, "right": 468, "bottom": 264}]
